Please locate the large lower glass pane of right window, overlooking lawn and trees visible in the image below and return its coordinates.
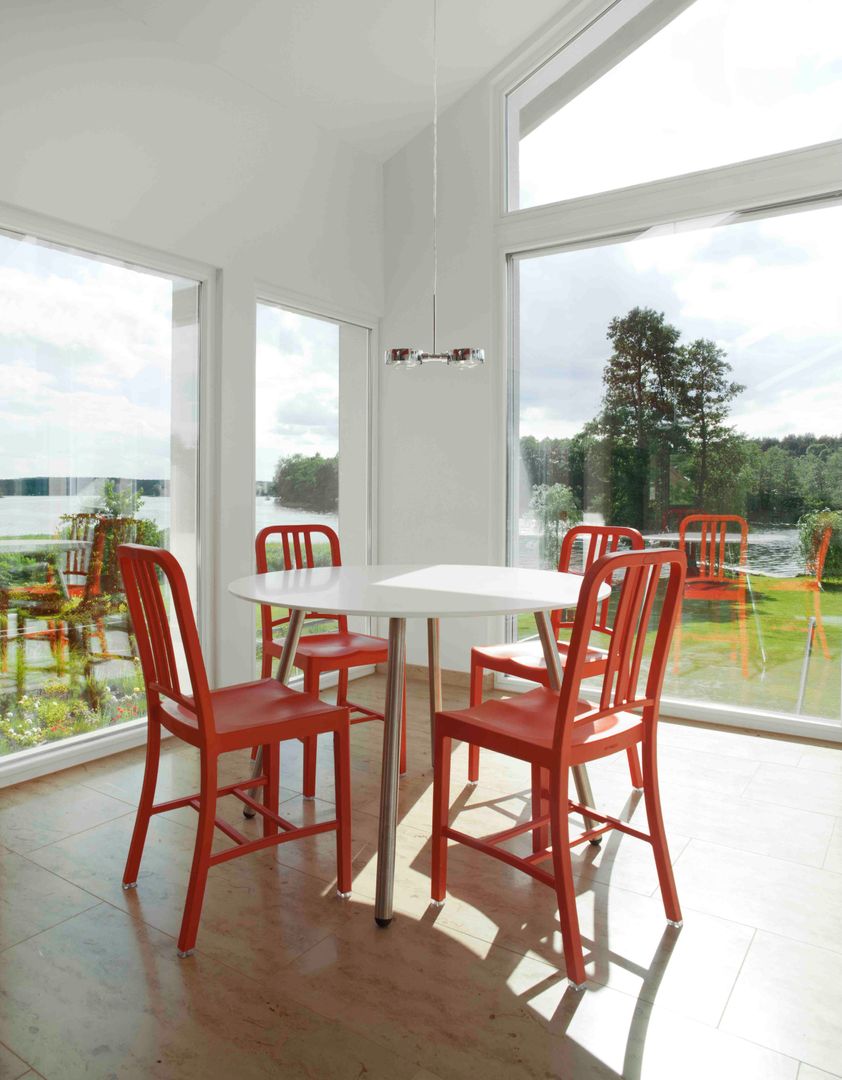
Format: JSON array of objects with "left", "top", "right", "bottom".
[{"left": 512, "top": 205, "right": 842, "bottom": 721}]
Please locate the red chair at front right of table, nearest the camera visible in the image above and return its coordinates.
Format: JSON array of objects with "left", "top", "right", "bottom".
[{"left": 432, "top": 550, "right": 685, "bottom": 989}]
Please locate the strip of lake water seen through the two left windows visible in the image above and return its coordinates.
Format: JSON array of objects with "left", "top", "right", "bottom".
[{"left": 0, "top": 495, "right": 337, "bottom": 537}]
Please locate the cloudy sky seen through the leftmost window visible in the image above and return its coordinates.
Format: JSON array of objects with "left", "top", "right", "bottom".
[{"left": 0, "top": 232, "right": 195, "bottom": 478}]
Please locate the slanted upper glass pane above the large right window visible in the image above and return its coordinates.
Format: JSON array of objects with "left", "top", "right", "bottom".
[{"left": 510, "top": 0, "right": 842, "bottom": 210}]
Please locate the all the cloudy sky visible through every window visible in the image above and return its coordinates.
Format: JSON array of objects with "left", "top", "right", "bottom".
[{"left": 0, "top": 0, "right": 842, "bottom": 480}]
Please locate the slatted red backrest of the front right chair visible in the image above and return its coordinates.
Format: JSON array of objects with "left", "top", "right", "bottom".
[{"left": 554, "top": 548, "right": 687, "bottom": 755}]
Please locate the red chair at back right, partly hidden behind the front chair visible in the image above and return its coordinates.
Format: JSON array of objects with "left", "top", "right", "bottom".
[{"left": 467, "top": 525, "right": 643, "bottom": 787}]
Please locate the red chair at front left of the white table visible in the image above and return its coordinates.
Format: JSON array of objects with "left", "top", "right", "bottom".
[{"left": 118, "top": 544, "right": 351, "bottom": 957}]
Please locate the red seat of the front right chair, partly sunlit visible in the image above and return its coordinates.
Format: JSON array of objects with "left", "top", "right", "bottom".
[{"left": 436, "top": 687, "right": 643, "bottom": 765}]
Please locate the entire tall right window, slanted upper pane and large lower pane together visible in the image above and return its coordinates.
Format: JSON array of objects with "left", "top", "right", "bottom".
[{"left": 505, "top": 0, "right": 842, "bottom": 729}]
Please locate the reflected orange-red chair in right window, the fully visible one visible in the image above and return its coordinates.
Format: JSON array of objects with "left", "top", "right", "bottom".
[{"left": 673, "top": 514, "right": 748, "bottom": 678}]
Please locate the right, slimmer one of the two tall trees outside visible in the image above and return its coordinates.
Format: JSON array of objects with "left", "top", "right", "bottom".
[{"left": 677, "top": 338, "right": 746, "bottom": 509}]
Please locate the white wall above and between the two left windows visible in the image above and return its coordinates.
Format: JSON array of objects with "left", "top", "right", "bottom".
[{"left": 0, "top": 0, "right": 382, "bottom": 681}]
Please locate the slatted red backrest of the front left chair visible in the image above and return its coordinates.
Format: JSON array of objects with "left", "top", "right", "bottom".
[{"left": 117, "top": 543, "right": 216, "bottom": 744}]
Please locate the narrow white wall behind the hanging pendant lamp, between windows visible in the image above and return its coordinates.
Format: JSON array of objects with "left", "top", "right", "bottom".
[{"left": 378, "top": 80, "right": 505, "bottom": 671}]
